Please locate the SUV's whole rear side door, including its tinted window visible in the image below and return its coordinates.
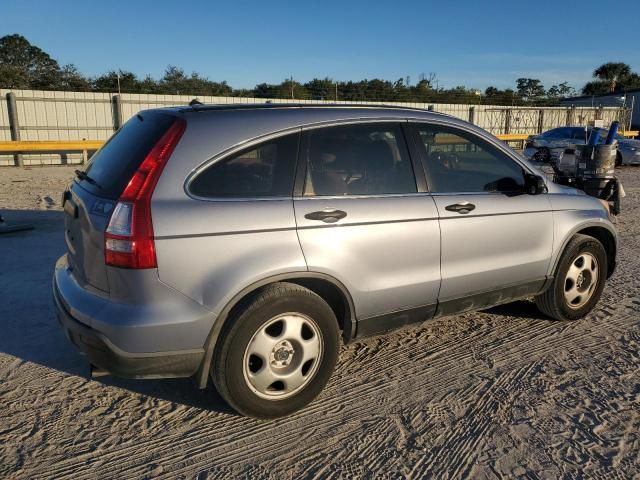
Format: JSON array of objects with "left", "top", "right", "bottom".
[{"left": 294, "top": 122, "right": 440, "bottom": 330}]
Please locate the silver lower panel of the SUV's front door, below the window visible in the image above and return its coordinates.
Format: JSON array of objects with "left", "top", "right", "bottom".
[{"left": 434, "top": 193, "right": 553, "bottom": 301}]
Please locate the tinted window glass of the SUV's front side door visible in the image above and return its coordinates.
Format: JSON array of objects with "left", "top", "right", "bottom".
[{"left": 417, "top": 126, "right": 524, "bottom": 193}]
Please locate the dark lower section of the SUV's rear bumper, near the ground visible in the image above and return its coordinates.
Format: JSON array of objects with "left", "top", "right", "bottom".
[{"left": 53, "top": 255, "right": 204, "bottom": 378}]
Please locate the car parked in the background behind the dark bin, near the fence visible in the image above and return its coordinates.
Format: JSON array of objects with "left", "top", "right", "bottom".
[{"left": 523, "top": 127, "right": 640, "bottom": 170}]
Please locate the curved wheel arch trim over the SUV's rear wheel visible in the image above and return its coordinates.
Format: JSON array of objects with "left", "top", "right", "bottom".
[{"left": 196, "top": 271, "right": 356, "bottom": 388}]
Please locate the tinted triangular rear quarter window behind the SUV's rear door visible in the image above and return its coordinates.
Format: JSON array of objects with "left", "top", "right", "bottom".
[{"left": 189, "top": 133, "right": 299, "bottom": 198}]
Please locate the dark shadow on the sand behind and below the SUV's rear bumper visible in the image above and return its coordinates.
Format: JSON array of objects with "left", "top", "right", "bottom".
[{"left": 0, "top": 210, "right": 232, "bottom": 413}]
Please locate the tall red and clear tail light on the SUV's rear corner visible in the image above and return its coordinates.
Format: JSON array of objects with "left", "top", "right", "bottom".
[{"left": 104, "top": 119, "right": 186, "bottom": 269}]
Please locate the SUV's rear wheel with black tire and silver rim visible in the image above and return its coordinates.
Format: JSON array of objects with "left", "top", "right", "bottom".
[{"left": 211, "top": 282, "right": 340, "bottom": 419}]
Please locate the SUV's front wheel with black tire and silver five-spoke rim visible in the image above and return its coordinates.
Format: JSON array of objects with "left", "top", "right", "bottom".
[{"left": 535, "top": 234, "right": 607, "bottom": 320}]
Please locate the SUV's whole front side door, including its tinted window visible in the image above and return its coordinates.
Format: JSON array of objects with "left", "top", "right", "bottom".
[{"left": 412, "top": 124, "right": 553, "bottom": 308}]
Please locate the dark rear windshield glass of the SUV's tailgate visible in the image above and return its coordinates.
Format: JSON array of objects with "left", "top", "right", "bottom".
[{"left": 82, "top": 112, "right": 180, "bottom": 200}]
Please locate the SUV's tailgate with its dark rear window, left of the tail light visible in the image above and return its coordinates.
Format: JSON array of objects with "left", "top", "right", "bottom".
[{"left": 64, "top": 112, "right": 175, "bottom": 292}]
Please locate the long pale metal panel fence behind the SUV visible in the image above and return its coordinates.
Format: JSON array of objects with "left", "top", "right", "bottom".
[{"left": 0, "top": 89, "right": 630, "bottom": 166}]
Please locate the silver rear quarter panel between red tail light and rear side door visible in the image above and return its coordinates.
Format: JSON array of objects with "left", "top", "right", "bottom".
[{"left": 153, "top": 198, "right": 307, "bottom": 313}]
